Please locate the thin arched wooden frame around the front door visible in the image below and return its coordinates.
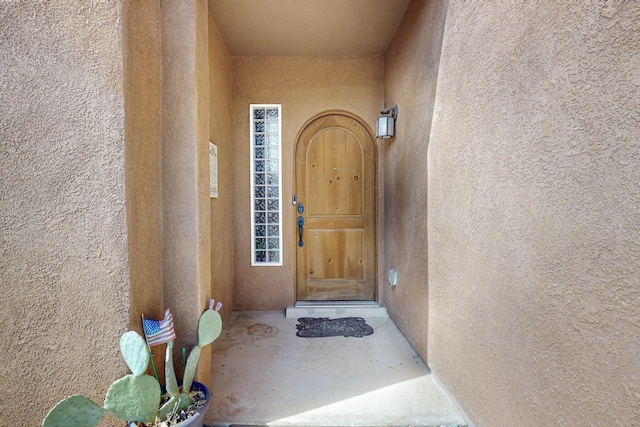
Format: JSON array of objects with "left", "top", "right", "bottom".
[{"left": 290, "top": 110, "right": 380, "bottom": 302}]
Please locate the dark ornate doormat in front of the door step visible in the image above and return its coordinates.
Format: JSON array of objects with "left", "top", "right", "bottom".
[{"left": 296, "top": 317, "right": 373, "bottom": 338}]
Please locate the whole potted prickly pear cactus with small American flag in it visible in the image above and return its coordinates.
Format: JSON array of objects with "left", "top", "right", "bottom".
[{"left": 42, "top": 300, "right": 222, "bottom": 427}]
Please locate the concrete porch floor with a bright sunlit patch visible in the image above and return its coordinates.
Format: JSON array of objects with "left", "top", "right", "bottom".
[{"left": 205, "top": 311, "right": 467, "bottom": 426}]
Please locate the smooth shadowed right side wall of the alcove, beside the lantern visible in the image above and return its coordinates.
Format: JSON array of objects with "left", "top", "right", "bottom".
[{"left": 379, "top": 0, "right": 446, "bottom": 361}]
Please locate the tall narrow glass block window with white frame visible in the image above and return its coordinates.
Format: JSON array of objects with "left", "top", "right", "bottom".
[{"left": 249, "top": 104, "right": 282, "bottom": 266}]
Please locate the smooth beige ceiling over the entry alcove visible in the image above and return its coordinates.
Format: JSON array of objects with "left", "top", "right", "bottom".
[{"left": 209, "top": 0, "right": 410, "bottom": 56}]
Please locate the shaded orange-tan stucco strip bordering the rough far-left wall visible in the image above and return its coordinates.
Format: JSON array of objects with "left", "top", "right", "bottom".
[{"left": 123, "top": 0, "right": 164, "bottom": 332}]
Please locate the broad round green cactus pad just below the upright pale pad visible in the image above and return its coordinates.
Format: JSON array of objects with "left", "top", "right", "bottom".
[{"left": 104, "top": 375, "right": 161, "bottom": 422}]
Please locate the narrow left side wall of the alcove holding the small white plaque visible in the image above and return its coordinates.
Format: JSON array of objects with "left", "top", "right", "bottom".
[{"left": 208, "top": 14, "right": 234, "bottom": 319}]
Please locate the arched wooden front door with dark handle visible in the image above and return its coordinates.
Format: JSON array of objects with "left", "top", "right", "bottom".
[{"left": 295, "top": 113, "right": 377, "bottom": 301}]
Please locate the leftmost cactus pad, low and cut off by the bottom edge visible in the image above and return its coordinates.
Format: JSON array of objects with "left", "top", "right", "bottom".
[{"left": 42, "top": 394, "right": 104, "bottom": 427}]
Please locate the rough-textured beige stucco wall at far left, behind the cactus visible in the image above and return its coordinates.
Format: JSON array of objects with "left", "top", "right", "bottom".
[{"left": 0, "top": 1, "right": 129, "bottom": 426}]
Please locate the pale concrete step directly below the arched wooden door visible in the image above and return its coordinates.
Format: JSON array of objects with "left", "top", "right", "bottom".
[{"left": 285, "top": 301, "right": 389, "bottom": 319}]
